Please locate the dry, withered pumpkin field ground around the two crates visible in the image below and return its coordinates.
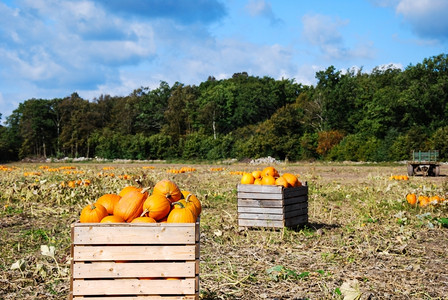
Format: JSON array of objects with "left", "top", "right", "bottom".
[{"left": 0, "top": 163, "right": 448, "bottom": 299}]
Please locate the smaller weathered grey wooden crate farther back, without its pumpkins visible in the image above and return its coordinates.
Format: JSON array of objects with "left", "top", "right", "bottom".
[{"left": 237, "top": 184, "right": 308, "bottom": 228}]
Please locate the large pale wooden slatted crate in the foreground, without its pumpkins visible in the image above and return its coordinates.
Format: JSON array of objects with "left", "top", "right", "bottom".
[{"left": 69, "top": 222, "right": 200, "bottom": 300}]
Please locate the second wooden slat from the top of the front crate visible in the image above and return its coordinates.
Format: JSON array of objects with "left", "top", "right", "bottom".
[{"left": 73, "top": 245, "right": 198, "bottom": 261}]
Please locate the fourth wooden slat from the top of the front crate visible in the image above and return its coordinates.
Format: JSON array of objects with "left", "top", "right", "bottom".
[{"left": 73, "top": 278, "right": 196, "bottom": 299}]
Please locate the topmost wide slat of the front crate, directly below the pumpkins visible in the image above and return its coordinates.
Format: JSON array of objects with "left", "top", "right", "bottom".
[{"left": 73, "top": 224, "right": 196, "bottom": 245}]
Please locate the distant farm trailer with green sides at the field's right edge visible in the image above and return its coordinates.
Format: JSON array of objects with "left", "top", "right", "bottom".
[{"left": 408, "top": 150, "right": 440, "bottom": 176}]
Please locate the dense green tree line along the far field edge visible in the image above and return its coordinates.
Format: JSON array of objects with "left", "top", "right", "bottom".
[{"left": 0, "top": 54, "right": 448, "bottom": 161}]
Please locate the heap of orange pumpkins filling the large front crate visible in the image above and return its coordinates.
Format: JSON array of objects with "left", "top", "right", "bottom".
[{"left": 80, "top": 179, "right": 202, "bottom": 223}]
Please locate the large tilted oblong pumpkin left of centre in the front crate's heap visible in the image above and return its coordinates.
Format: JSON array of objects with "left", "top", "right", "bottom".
[{"left": 114, "top": 190, "right": 148, "bottom": 222}]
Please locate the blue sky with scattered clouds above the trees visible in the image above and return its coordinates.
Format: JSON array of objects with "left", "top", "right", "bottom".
[{"left": 0, "top": 0, "right": 448, "bottom": 121}]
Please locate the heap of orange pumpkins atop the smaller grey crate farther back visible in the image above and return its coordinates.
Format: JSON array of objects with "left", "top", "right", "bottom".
[{"left": 241, "top": 166, "right": 302, "bottom": 188}]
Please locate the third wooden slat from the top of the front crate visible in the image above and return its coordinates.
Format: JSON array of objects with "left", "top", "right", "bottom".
[{"left": 73, "top": 261, "right": 196, "bottom": 279}]
